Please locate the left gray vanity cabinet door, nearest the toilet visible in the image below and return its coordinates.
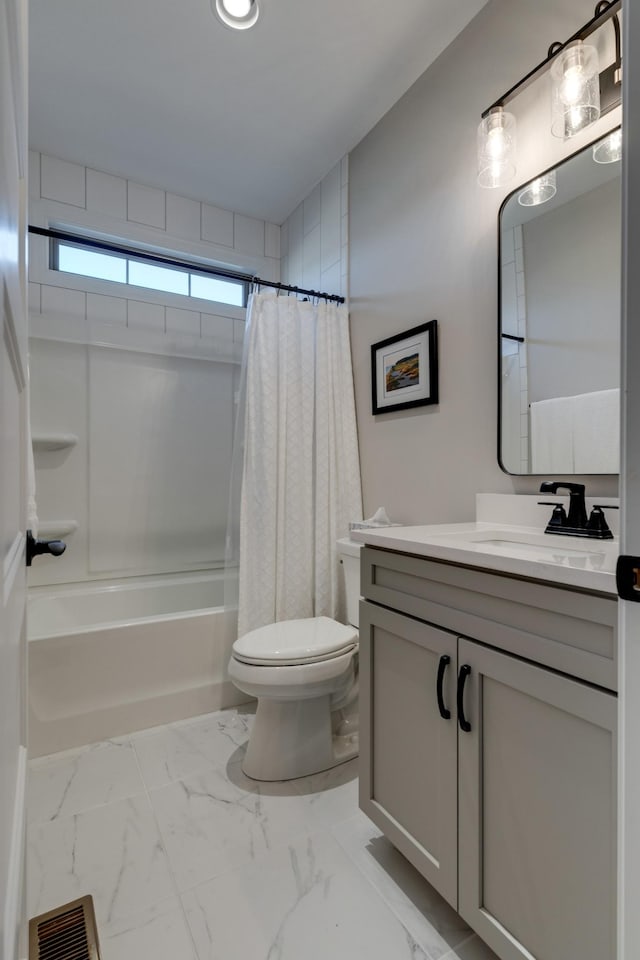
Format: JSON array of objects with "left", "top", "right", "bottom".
[{"left": 360, "top": 602, "right": 457, "bottom": 907}]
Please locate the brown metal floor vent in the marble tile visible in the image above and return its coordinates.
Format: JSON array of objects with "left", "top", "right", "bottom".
[{"left": 29, "top": 896, "right": 100, "bottom": 960}]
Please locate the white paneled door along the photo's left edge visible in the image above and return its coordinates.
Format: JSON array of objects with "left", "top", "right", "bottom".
[{"left": 0, "top": 0, "right": 27, "bottom": 960}]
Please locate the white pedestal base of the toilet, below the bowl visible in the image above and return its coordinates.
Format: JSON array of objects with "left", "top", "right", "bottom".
[{"left": 242, "top": 695, "right": 358, "bottom": 781}]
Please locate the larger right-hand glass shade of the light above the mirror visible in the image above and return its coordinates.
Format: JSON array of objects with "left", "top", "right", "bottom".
[{"left": 551, "top": 40, "right": 600, "bottom": 140}]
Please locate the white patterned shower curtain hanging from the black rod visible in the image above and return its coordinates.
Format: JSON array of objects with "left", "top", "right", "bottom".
[{"left": 238, "top": 293, "right": 362, "bottom": 636}]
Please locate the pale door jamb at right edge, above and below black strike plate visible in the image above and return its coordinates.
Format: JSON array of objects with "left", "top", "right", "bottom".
[{"left": 618, "top": 3, "right": 640, "bottom": 960}]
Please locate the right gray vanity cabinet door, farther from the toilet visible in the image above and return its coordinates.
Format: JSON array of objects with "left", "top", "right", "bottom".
[{"left": 458, "top": 640, "right": 616, "bottom": 960}]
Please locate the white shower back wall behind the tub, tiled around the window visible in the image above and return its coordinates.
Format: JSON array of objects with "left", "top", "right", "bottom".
[{"left": 29, "top": 152, "right": 280, "bottom": 585}]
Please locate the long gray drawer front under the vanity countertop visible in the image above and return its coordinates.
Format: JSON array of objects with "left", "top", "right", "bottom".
[{"left": 361, "top": 547, "right": 617, "bottom": 690}]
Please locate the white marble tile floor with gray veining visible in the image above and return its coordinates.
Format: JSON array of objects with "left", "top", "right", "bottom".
[{"left": 27, "top": 707, "right": 496, "bottom": 960}]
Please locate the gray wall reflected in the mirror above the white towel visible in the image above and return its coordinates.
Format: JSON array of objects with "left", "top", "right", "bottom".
[{"left": 523, "top": 179, "right": 621, "bottom": 402}]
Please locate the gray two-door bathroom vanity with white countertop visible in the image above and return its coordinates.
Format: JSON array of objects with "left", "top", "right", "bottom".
[{"left": 358, "top": 508, "right": 618, "bottom": 960}]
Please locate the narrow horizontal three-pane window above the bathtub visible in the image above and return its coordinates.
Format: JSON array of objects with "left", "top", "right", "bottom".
[{"left": 50, "top": 240, "right": 249, "bottom": 307}]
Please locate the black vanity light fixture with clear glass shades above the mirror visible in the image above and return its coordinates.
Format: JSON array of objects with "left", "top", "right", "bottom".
[{"left": 478, "top": 0, "right": 622, "bottom": 189}]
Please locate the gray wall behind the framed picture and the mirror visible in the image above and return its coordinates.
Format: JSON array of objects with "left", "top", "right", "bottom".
[{"left": 350, "top": 0, "right": 619, "bottom": 522}]
